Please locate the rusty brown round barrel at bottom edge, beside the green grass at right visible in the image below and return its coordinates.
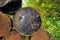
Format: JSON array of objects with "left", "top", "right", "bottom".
[{"left": 30, "top": 29, "right": 53, "bottom": 40}]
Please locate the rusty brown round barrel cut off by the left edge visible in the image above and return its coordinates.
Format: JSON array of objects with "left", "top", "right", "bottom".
[{"left": 0, "top": 12, "right": 11, "bottom": 37}]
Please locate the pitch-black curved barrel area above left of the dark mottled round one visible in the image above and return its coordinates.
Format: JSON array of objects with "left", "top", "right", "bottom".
[{"left": 0, "top": 0, "right": 22, "bottom": 14}]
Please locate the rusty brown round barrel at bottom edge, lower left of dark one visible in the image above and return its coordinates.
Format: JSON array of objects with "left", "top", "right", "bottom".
[{"left": 3, "top": 31, "right": 24, "bottom": 40}]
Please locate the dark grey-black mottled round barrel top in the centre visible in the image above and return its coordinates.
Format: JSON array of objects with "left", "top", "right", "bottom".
[{"left": 13, "top": 7, "right": 41, "bottom": 36}]
